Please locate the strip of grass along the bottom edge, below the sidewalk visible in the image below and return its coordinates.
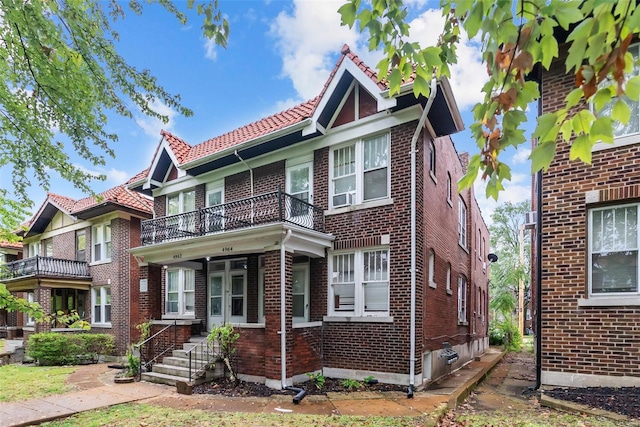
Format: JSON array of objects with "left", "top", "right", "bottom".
[{"left": 41, "top": 404, "right": 424, "bottom": 427}]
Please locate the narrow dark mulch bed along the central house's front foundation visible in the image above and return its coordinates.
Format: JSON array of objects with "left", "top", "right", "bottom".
[{"left": 193, "top": 378, "right": 407, "bottom": 397}]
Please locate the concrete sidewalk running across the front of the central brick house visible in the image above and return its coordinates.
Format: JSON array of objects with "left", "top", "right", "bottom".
[{"left": 0, "top": 349, "right": 504, "bottom": 427}]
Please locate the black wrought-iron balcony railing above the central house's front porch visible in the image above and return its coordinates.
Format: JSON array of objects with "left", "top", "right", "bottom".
[{"left": 141, "top": 191, "right": 324, "bottom": 246}]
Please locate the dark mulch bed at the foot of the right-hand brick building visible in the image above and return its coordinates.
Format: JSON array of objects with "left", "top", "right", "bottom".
[{"left": 544, "top": 387, "right": 640, "bottom": 418}]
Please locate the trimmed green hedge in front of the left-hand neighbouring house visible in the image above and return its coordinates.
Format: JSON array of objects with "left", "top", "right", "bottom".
[{"left": 27, "top": 332, "right": 115, "bottom": 365}]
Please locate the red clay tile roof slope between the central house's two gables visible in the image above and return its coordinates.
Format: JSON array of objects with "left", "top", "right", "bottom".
[{"left": 186, "top": 97, "right": 320, "bottom": 162}]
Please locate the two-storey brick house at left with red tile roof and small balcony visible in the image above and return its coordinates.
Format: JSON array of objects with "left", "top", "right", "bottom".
[{"left": 0, "top": 185, "right": 152, "bottom": 355}]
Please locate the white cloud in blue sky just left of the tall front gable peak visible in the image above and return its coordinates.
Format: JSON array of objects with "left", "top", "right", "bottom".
[{"left": 270, "top": 0, "right": 370, "bottom": 100}]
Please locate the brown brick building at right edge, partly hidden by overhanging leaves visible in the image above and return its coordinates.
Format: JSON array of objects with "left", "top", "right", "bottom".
[{"left": 532, "top": 44, "right": 640, "bottom": 386}]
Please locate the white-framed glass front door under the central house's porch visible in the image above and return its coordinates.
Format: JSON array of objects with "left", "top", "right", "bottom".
[{"left": 208, "top": 259, "right": 247, "bottom": 329}]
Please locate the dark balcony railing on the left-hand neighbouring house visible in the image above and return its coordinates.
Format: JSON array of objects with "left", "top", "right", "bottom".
[{"left": 0, "top": 255, "right": 90, "bottom": 280}]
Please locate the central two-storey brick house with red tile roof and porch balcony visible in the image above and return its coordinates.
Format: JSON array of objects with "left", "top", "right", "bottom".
[{"left": 129, "top": 46, "right": 489, "bottom": 388}]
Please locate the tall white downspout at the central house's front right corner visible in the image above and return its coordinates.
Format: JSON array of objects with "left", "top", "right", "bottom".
[{"left": 407, "top": 77, "right": 438, "bottom": 399}]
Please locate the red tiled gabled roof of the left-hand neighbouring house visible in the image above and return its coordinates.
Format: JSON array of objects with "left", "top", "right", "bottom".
[{"left": 19, "top": 184, "right": 153, "bottom": 237}]
